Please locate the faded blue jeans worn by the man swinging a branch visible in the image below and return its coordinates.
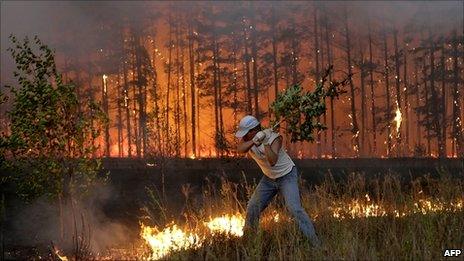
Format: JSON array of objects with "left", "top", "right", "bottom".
[{"left": 244, "top": 166, "right": 320, "bottom": 246}]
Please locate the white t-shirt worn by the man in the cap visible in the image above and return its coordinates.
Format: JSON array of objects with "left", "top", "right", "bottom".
[{"left": 248, "top": 132, "right": 295, "bottom": 179}]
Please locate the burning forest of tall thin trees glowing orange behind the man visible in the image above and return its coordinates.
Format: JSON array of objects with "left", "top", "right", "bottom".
[{"left": 1, "top": 1, "right": 464, "bottom": 158}]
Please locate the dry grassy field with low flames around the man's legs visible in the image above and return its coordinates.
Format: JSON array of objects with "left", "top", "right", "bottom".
[{"left": 1, "top": 159, "right": 464, "bottom": 260}]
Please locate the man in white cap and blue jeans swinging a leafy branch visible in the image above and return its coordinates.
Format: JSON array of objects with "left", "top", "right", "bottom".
[{"left": 235, "top": 115, "right": 320, "bottom": 246}]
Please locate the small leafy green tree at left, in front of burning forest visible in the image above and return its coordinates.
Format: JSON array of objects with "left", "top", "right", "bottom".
[{"left": 2, "top": 36, "right": 107, "bottom": 201}]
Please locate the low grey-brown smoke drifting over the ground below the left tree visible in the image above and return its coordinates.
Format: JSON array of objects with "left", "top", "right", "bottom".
[{"left": 5, "top": 181, "right": 138, "bottom": 253}]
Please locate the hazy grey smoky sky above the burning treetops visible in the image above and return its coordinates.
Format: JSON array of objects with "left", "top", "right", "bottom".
[{"left": 0, "top": 1, "right": 464, "bottom": 88}]
